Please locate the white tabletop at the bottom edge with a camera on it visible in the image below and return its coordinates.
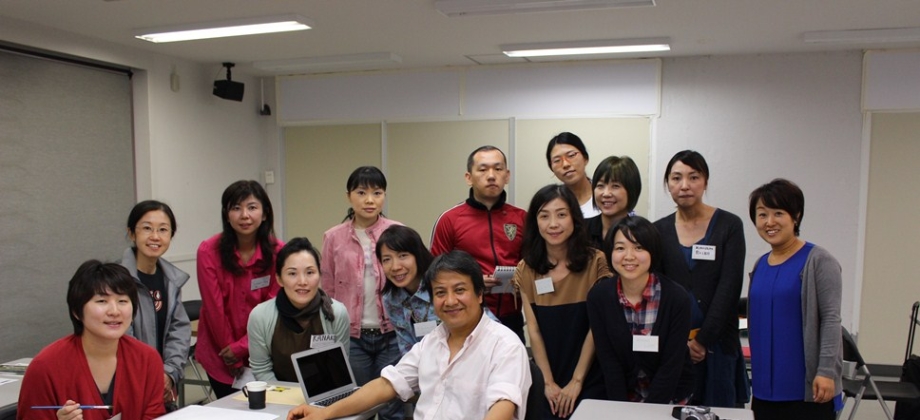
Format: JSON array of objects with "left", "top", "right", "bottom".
[{"left": 571, "top": 400, "right": 754, "bottom": 420}]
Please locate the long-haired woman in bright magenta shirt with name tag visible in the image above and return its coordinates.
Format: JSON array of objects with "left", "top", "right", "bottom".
[{"left": 195, "top": 181, "right": 282, "bottom": 398}]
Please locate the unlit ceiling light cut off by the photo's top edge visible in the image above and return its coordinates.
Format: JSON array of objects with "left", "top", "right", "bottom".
[{"left": 434, "top": 0, "right": 655, "bottom": 17}]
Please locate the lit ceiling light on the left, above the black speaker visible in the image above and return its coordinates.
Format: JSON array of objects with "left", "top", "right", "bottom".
[{"left": 135, "top": 15, "right": 313, "bottom": 43}]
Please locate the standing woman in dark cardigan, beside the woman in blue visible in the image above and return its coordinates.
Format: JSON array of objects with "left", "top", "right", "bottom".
[{"left": 655, "top": 150, "right": 750, "bottom": 407}]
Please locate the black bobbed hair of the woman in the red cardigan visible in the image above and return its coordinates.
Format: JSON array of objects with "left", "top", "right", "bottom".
[{"left": 67, "top": 260, "right": 137, "bottom": 335}]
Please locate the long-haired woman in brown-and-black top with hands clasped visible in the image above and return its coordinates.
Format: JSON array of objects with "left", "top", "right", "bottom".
[{"left": 513, "top": 185, "right": 611, "bottom": 418}]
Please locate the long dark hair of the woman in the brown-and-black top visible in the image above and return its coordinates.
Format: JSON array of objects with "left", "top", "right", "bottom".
[{"left": 521, "top": 184, "right": 592, "bottom": 274}]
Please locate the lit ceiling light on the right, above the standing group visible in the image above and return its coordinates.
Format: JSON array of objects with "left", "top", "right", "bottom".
[{"left": 501, "top": 38, "right": 671, "bottom": 57}]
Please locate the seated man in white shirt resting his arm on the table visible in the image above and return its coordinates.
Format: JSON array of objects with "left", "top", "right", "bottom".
[{"left": 288, "top": 251, "right": 531, "bottom": 420}]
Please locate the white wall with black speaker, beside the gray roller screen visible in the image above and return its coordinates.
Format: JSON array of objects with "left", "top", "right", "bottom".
[{"left": 0, "top": 17, "right": 280, "bottom": 299}]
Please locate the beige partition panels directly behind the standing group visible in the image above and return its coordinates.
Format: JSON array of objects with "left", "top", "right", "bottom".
[{"left": 284, "top": 118, "right": 655, "bottom": 249}]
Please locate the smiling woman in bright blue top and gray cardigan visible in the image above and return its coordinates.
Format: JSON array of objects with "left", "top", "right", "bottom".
[{"left": 748, "top": 179, "right": 843, "bottom": 420}]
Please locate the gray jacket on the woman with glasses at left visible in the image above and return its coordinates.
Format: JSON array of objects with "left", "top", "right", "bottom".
[{"left": 121, "top": 248, "right": 192, "bottom": 385}]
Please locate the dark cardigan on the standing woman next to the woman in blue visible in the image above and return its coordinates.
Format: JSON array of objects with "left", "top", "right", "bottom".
[{"left": 655, "top": 209, "right": 745, "bottom": 354}]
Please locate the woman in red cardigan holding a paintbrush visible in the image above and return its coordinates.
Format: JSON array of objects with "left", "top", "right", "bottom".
[{"left": 16, "top": 260, "right": 166, "bottom": 420}]
